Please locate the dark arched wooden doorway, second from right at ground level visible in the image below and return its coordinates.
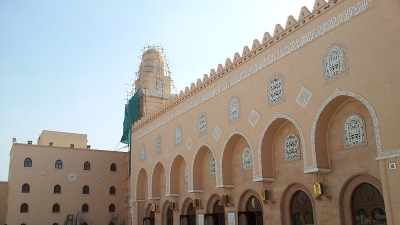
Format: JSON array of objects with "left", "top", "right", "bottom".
[{"left": 290, "top": 191, "right": 314, "bottom": 225}]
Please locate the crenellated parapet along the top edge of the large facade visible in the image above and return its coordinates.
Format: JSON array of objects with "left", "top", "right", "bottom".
[{"left": 133, "top": 0, "right": 360, "bottom": 134}]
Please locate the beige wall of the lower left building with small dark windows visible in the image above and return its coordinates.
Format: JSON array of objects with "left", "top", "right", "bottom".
[{"left": 6, "top": 144, "right": 129, "bottom": 224}]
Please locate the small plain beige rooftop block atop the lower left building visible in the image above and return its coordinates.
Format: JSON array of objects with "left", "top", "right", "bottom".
[{"left": 37, "top": 130, "right": 87, "bottom": 148}]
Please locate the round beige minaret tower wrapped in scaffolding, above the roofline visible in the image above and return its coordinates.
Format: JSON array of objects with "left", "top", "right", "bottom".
[{"left": 135, "top": 46, "right": 174, "bottom": 116}]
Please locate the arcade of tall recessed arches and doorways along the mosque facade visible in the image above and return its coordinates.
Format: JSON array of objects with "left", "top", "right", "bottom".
[{"left": 132, "top": 93, "right": 387, "bottom": 225}]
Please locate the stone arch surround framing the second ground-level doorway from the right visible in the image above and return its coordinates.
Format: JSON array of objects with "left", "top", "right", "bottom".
[{"left": 280, "top": 182, "right": 317, "bottom": 225}]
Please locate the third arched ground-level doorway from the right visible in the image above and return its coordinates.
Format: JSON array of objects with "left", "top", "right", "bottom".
[{"left": 238, "top": 195, "right": 263, "bottom": 225}]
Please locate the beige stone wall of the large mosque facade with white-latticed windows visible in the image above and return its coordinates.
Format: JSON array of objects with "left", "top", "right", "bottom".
[{"left": 131, "top": 0, "right": 400, "bottom": 224}]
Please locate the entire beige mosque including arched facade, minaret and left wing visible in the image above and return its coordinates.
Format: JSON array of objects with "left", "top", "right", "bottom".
[{"left": 0, "top": 0, "right": 400, "bottom": 225}]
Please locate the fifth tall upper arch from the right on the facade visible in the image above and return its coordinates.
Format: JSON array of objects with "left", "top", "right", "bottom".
[{"left": 167, "top": 152, "right": 191, "bottom": 196}]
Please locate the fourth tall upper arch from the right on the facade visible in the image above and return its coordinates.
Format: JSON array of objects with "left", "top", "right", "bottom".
[{"left": 190, "top": 142, "right": 218, "bottom": 192}]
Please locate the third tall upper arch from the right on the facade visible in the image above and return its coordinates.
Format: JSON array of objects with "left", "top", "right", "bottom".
[{"left": 217, "top": 129, "right": 255, "bottom": 187}]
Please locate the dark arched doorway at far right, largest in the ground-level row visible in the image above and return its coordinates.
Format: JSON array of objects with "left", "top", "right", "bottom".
[{"left": 351, "top": 183, "right": 387, "bottom": 225}]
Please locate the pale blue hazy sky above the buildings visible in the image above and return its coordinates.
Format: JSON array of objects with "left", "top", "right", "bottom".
[{"left": 0, "top": 0, "right": 315, "bottom": 181}]
